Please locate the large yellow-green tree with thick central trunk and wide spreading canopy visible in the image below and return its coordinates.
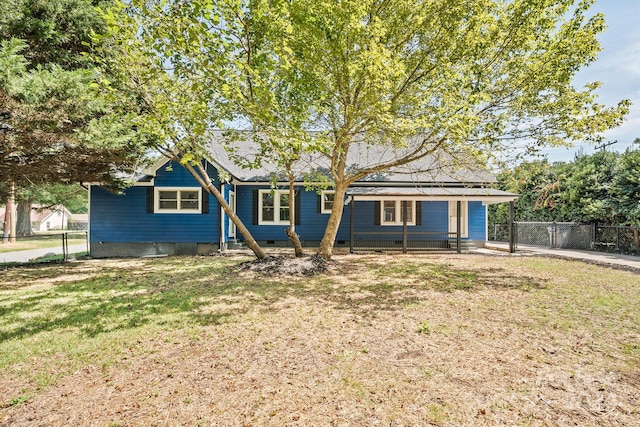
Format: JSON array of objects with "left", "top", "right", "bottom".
[{"left": 106, "top": 0, "right": 629, "bottom": 258}]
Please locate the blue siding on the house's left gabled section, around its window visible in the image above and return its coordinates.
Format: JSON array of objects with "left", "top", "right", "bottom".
[{"left": 89, "top": 163, "right": 218, "bottom": 243}]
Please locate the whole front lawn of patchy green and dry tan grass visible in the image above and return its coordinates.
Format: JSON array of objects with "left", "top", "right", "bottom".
[{"left": 0, "top": 255, "right": 640, "bottom": 426}]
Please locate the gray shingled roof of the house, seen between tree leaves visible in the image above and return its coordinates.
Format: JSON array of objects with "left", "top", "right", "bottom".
[{"left": 208, "top": 131, "right": 496, "bottom": 185}]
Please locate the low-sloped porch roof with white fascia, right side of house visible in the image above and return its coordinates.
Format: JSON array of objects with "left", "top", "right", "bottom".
[{"left": 347, "top": 187, "right": 518, "bottom": 204}]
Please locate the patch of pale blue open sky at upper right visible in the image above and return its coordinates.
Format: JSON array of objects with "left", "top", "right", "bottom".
[{"left": 543, "top": 0, "right": 640, "bottom": 161}]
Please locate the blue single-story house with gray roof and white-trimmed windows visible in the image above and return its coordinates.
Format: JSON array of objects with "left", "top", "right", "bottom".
[{"left": 89, "top": 134, "right": 517, "bottom": 258}]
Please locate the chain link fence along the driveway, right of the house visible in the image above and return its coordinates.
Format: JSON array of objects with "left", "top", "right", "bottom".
[{"left": 489, "top": 222, "right": 640, "bottom": 255}]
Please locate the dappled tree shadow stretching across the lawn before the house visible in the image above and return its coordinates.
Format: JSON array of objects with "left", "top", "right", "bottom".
[{"left": 0, "top": 257, "right": 545, "bottom": 342}]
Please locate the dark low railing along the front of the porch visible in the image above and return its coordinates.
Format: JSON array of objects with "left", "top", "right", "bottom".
[{"left": 350, "top": 231, "right": 459, "bottom": 253}]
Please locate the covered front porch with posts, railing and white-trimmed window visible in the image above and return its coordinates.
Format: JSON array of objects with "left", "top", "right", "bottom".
[{"left": 345, "top": 186, "right": 517, "bottom": 253}]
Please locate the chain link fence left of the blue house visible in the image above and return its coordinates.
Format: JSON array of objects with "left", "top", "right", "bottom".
[{"left": 0, "top": 231, "right": 89, "bottom": 266}]
